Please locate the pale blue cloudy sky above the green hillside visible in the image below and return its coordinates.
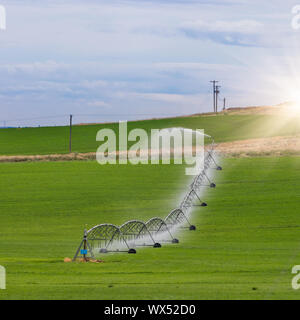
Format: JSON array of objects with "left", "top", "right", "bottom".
[{"left": 0, "top": 0, "right": 300, "bottom": 127}]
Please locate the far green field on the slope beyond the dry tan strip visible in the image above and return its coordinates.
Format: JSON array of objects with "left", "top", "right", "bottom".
[{"left": 0, "top": 115, "right": 300, "bottom": 155}]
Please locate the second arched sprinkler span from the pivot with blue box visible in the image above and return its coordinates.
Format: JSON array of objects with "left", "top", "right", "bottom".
[{"left": 120, "top": 220, "right": 161, "bottom": 248}]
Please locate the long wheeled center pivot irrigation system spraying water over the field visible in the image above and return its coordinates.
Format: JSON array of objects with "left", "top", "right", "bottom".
[{"left": 73, "top": 131, "right": 222, "bottom": 261}]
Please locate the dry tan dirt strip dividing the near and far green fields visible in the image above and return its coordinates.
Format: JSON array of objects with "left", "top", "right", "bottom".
[{"left": 0, "top": 136, "right": 300, "bottom": 162}]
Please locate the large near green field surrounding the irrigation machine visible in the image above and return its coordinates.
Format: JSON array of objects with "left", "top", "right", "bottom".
[{"left": 0, "top": 156, "right": 300, "bottom": 299}]
